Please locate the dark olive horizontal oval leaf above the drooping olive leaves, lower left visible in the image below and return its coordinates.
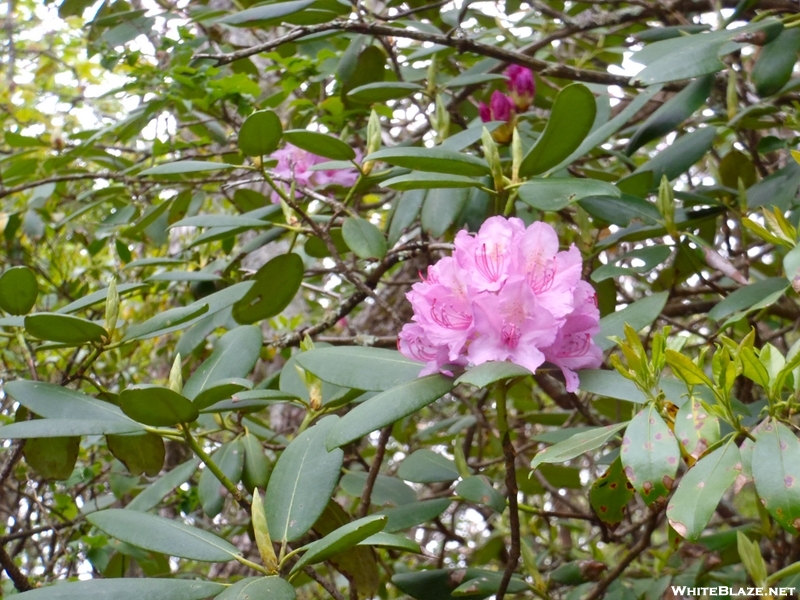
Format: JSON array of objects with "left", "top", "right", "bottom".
[{"left": 119, "top": 385, "right": 200, "bottom": 427}]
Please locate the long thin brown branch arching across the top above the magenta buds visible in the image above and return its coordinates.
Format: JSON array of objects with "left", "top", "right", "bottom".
[{"left": 194, "top": 21, "right": 643, "bottom": 88}]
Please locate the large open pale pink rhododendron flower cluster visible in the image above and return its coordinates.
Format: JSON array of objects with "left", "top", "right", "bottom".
[{"left": 398, "top": 217, "right": 602, "bottom": 392}]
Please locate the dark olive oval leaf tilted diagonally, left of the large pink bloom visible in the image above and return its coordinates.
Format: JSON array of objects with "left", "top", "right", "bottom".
[{"left": 233, "top": 252, "right": 303, "bottom": 324}]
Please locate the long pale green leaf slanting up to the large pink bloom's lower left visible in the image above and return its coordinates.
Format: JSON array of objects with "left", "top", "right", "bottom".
[{"left": 327, "top": 375, "right": 453, "bottom": 448}]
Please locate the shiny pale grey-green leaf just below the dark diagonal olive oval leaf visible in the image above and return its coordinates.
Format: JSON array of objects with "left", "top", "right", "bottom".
[{"left": 183, "top": 325, "right": 262, "bottom": 400}]
